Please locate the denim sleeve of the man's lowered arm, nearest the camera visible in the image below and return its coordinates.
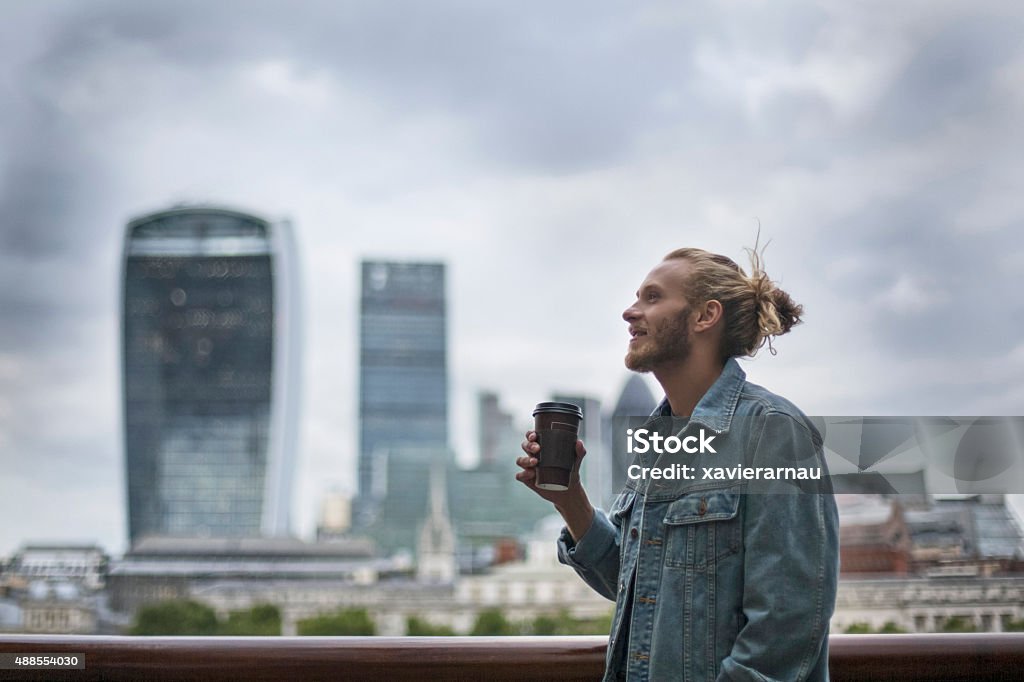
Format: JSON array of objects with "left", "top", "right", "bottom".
[{"left": 718, "top": 413, "right": 839, "bottom": 682}]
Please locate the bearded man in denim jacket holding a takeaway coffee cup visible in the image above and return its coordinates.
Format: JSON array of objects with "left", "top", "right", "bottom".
[{"left": 516, "top": 249, "right": 839, "bottom": 682}]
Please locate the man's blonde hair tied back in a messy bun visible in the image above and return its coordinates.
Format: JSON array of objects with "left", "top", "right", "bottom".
[{"left": 665, "top": 244, "right": 804, "bottom": 360}]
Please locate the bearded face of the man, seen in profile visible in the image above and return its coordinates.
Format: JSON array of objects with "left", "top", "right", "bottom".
[{"left": 623, "top": 259, "right": 690, "bottom": 372}]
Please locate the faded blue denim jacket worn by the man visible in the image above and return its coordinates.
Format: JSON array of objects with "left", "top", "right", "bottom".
[{"left": 558, "top": 358, "right": 839, "bottom": 682}]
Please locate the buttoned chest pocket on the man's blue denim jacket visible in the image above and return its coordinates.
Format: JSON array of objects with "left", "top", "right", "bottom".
[{"left": 664, "top": 487, "right": 742, "bottom": 569}]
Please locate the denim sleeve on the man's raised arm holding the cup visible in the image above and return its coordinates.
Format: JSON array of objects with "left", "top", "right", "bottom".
[{"left": 558, "top": 493, "right": 636, "bottom": 601}]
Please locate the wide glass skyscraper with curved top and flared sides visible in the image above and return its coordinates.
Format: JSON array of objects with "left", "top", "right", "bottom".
[{"left": 122, "top": 207, "right": 299, "bottom": 545}]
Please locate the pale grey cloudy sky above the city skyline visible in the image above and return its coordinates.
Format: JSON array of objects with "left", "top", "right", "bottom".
[{"left": 0, "top": 0, "right": 1024, "bottom": 555}]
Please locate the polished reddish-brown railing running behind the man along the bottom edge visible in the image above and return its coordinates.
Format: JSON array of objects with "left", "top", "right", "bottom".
[{"left": 0, "top": 633, "right": 1024, "bottom": 682}]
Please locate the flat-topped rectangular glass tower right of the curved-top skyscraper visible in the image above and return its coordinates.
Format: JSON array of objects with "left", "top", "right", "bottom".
[{"left": 358, "top": 261, "right": 447, "bottom": 503}]
